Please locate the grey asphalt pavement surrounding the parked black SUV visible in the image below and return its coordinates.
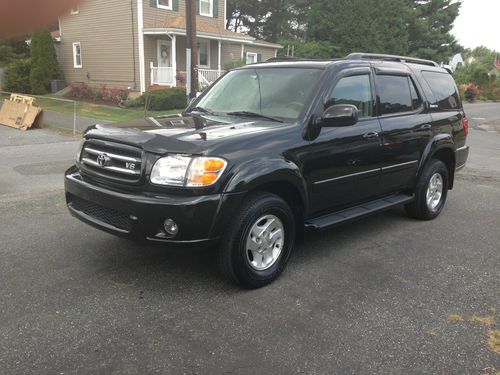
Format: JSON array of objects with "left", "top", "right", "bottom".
[{"left": 0, "top": 104, "right": 500, "bottom": 374}]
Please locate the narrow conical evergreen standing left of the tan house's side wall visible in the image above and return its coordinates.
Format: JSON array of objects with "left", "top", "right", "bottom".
[{"left": 30, "top": 30, "right": 60, "bottom": 94}]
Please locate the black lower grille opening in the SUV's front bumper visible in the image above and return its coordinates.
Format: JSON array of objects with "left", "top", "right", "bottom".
[{"left": 69, "top": 197, "right": 133, "bottom": 232}]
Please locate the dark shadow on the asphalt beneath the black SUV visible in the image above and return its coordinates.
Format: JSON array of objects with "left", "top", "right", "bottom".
[{"left": 82, "top": 208, "right": 413, "bottom": 293}]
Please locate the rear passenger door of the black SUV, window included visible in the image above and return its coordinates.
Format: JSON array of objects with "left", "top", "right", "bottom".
[{"left": 375, "top": 69, "right": 433, "bottom": 195}]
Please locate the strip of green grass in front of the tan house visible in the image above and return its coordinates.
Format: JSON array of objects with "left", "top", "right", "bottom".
[{"left": 0, "top": 95, "right": 182, "bottom": 122}]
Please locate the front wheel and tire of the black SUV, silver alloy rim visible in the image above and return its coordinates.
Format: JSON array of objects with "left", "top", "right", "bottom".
[{"left": 218, "top": 193, "right": 295, "bottom": 289}]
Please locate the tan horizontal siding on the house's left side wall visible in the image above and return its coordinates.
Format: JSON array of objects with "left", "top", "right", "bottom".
[{"left": 60, "top": 0, "right": 139, "bottom": 89}]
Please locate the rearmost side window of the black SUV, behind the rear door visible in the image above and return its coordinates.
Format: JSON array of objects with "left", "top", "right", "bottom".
[{"left": 422, "top": 72, "right": 460, "bottom": 110}]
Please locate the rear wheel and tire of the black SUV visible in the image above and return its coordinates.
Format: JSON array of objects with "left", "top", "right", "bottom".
[{"left": 405, "top": 159, "right": 448, "bottom": 220}]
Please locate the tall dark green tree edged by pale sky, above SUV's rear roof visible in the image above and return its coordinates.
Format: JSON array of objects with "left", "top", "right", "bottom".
[{"left": 408, "top": 0, "right": 462, "bottom": 62}]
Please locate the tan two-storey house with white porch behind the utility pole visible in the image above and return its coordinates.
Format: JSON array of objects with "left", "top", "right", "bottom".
[{"left": 60, "top": 0, "right": 282, "bottom": 92}]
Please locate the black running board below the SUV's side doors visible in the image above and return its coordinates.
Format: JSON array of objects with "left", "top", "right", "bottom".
[{"left": 304, "top": 194, "right": 413, "bottom": 230}]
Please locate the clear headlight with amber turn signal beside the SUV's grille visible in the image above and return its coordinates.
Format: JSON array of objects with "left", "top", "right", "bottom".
[{"left": 150, "top": 155, "right": 227, "bottom": 187}]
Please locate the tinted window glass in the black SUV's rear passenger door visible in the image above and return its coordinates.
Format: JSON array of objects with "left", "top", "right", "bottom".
[{"left": 376, "top": 75, "right": 413, "bottom": 115}]
